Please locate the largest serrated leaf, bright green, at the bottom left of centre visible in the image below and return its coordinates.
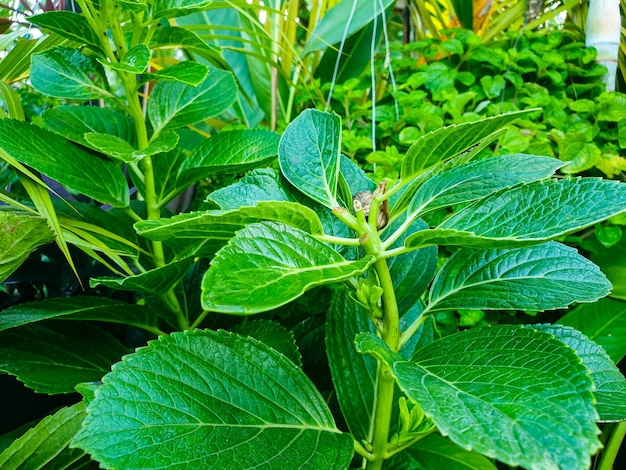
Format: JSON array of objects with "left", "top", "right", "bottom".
[{"left": 73, "top": 330, "right": 354, "bottom": 469}]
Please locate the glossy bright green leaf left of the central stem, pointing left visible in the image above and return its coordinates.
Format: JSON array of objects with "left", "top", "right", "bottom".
[{"left": 202, "top": 222, "right": 373, "bottom": 315}]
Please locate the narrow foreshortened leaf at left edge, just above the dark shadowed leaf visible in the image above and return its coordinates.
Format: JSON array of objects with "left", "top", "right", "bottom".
[{"left": 0, "top": 295, "right": 157, "bottom": 331}]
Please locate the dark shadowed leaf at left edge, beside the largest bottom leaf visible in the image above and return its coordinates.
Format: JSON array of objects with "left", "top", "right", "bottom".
[{"left": 0, "top": 320, "right": 128, "bottom": 394}]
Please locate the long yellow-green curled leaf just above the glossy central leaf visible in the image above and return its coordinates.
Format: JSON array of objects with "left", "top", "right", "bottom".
[{"left": 135, "top": 201, "right": 323, "bottom": 241}]
